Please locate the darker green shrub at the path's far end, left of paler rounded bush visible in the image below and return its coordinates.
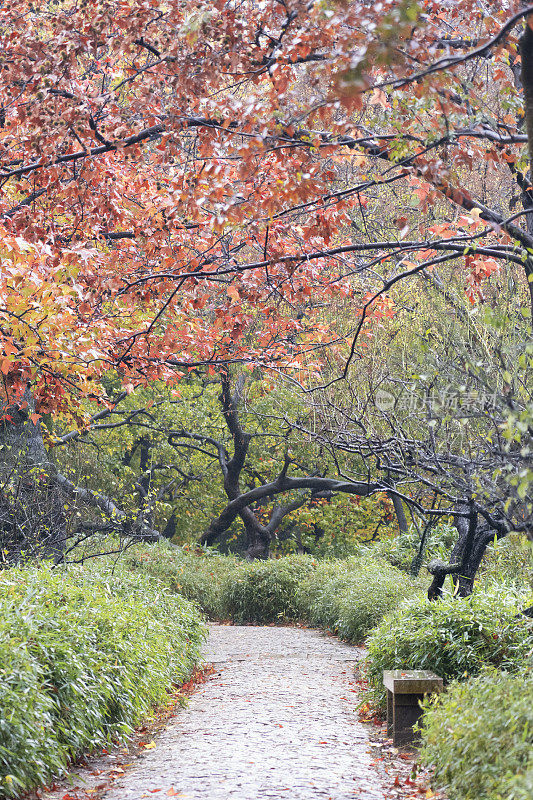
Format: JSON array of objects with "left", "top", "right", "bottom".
[{"left": 224, "top": 555, "right": 316, "bottom": 623}]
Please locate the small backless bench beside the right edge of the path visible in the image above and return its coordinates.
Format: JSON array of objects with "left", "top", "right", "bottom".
[{"left": 383, "top": 669, "right": 442, "bottom": 747}]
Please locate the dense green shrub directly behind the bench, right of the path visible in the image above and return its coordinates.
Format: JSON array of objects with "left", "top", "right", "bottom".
[{"left": 367, "top": 591, "right": 533, "bottom": 705}]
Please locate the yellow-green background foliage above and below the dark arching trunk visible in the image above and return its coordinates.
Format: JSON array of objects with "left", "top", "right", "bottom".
[{"left": 55, "top": 372, "right": 404, "bottom": 558}]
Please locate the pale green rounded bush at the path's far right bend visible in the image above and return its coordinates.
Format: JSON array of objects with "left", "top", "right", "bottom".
[{"left": 297, "top": 559, "right": 417, "bottom": 642}]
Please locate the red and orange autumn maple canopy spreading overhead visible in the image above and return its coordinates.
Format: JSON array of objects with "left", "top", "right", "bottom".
[{"left": 0, "top": 0, "right": 533, "bottom": 564}]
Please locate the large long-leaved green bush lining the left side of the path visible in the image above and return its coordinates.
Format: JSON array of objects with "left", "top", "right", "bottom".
[{"left": 0, "top": 566, "right": 204, "bottom": 796}]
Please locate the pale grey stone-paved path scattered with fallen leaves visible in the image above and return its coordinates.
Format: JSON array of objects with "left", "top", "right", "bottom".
[{"left": 105, "top": 625, "right": 388, "bottom": 800}]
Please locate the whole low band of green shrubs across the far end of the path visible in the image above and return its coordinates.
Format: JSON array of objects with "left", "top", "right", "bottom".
[{"left": 118, "top": 544, "right": 421, "bottom": 642}]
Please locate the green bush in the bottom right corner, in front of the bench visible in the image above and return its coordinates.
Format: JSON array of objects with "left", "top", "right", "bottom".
[{"left": 421, "top": 670, "right": 533, "bottom": 800}]
